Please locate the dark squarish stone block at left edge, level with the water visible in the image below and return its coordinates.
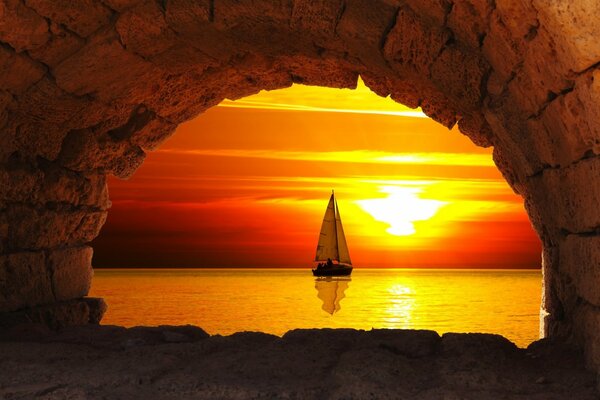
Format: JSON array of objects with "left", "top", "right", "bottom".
[{"left": 0, "top": 252, "right": 54, "bottom": 312}]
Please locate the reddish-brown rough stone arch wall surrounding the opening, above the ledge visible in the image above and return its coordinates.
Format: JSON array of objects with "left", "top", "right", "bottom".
[{"left": 0, "top": 0, "right": 600, "bottom": 366}]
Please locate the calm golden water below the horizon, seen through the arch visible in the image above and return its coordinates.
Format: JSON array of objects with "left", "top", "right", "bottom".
[{"left": 91, "top": 269, "right": 541, "bottom": 346}]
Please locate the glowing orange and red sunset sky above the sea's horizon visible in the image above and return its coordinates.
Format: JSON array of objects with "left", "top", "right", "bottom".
[{"left": 93, "top": 83, "right": 541, "bottom": 268}]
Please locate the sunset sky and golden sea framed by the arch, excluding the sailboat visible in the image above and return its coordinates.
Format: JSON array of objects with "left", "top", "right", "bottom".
[{"left": 92, "top": 79, "right": 540, "bottom": 346}]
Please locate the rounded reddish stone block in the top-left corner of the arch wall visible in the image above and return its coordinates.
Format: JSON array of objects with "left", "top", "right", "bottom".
[{"left": 0, "top": 0, "right": 50, "bottom": 53}]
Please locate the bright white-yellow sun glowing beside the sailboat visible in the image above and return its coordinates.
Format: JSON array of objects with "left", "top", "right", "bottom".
[{"left": 356, "top": 186, "right": 446, "bottom": 236}]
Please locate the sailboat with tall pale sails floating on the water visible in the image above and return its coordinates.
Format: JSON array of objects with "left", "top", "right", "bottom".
[{"left": 312, "top": 190, "right": 352, "bottom": 276}]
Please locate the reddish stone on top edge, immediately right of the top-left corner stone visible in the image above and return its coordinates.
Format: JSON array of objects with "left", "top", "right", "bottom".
[{"left": 25, "top": 0, "right": 112, "bottom": 37}]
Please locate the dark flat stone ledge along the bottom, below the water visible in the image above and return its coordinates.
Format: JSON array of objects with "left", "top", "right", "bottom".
[{"left": 0, "top": 325, "right": 598, "bottom": 400}]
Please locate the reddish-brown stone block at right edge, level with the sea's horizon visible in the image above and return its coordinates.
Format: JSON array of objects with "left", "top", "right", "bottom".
[{"left": 560, "top": 233, "right": 600, "bottom": 307}]
